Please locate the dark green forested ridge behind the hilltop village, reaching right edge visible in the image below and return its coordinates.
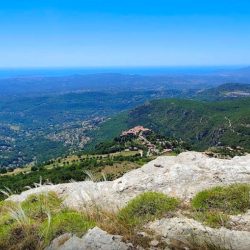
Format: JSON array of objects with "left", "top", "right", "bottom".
[{"left": 90, "top": 98, "right": 250, "bottom": 151}]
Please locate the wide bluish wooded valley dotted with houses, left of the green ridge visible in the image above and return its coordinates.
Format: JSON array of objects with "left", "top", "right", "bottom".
[{"left": 0, "top": 91, "right": 171, "bottom": 168}]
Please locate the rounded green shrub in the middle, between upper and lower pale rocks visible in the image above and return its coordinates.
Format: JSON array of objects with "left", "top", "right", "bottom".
[{"left": 118, "top": 192, "right": 179, "bottom": 226}]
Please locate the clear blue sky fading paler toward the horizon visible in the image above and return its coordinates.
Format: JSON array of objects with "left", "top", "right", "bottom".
[{"left": 0, "top": 0, "right": 250, "bottom": 67}]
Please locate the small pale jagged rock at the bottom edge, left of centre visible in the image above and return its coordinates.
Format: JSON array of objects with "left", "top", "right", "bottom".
[{"left": 46, "top": 227, "right": 133, "bottom": 250}]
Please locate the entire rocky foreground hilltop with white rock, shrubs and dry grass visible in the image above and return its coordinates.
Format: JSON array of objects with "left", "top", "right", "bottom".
[{"left": 0, "top": 152, "right": 250, "bottom": 250}]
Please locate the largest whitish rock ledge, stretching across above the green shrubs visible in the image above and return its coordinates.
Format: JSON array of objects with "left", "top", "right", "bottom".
[{"left": 9, "top": 152, "right": 250, "bottom": 209}]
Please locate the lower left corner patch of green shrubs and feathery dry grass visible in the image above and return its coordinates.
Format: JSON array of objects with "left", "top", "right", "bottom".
[{"left": 0, "top": 192, "right": 95, "bottom": 250}]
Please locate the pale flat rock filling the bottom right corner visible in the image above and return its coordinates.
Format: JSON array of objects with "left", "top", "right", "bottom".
[{"left": 147, "top": 218, "right": 250, "bottom": 250}]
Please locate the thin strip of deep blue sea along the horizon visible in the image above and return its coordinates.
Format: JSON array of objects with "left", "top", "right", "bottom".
[{"left": 0, "top": 66, "right": 243, "bottom": 78}]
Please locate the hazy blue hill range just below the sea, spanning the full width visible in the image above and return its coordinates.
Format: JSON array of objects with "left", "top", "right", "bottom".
[{"left": 0, "top": 68, "right": 250, "bottom": 99}]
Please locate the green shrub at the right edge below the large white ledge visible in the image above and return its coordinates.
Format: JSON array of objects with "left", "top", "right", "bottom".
[{"left": 192, "top": 184, "right": 250, "bottom": 214}]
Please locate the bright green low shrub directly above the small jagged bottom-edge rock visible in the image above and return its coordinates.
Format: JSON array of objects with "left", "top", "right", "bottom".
[{"left": 41, "top": 211, "right": 95, "bottom": 242}]
